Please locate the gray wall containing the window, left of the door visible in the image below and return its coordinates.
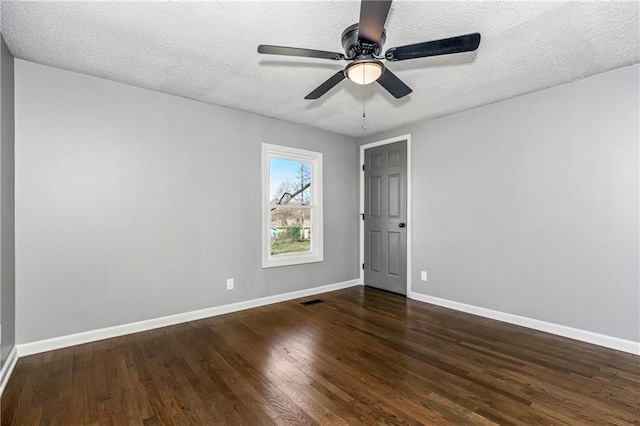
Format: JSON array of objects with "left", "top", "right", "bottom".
[{"left": 15, "top": 60, "right": 359, "bottom": 343}]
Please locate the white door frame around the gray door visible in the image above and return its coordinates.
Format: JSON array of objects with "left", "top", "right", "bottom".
[{"left": 359, "top": 133, "right": 413, "bottom": 298}]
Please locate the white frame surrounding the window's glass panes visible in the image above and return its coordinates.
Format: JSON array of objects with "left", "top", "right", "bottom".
[{"left": 262, "top": 143, "right": 324, "bottom": 268}]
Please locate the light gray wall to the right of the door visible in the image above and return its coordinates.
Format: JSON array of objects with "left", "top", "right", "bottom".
[{"left": 360, "top": 65, "right": 640, "bottom": 341}]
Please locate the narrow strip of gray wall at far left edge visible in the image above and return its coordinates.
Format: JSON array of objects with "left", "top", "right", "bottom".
[{"left": 0, "top": 35, "right": 16, "bottom": 366}]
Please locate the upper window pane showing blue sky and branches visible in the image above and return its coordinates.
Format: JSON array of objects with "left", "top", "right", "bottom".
[{"left": 269, "top": 158, "right": 311, "bottom": 205}]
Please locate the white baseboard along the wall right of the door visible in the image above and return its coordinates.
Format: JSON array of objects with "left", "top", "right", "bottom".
[{"left": 408, "top": 292, "right": 640, "bottom": 355}]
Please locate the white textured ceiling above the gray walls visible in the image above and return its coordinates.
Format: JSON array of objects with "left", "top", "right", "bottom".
[{"left": 2, "top": 1, "right": 640, "bottom": 136}]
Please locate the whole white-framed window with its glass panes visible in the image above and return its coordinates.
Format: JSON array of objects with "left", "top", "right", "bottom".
[{"left": 262, "top": 144, "right": 323, "bottom": 268}]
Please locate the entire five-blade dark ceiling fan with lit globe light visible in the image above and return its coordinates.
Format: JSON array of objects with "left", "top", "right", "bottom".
[{"left": 258, "top": 0, "right": 480, "bottom": 99}]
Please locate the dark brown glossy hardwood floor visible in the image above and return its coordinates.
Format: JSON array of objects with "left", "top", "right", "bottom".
[{"left": 1, "top": 287, "right": 640, "bottom": 425}]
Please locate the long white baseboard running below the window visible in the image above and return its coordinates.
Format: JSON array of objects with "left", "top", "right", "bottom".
[{"left": 18, "top": 279, "right": 362, "bottom": 357}]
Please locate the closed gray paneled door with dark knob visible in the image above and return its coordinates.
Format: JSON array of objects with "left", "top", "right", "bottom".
[{"left": 364, "top": 141, "right": 411, "bottom": 294}]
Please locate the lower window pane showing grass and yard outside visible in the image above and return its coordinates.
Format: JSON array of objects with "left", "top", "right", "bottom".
[{"left": 270, "top": 207, "right": 311, "bottom": 255}]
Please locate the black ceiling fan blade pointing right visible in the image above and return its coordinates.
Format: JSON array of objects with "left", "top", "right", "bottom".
[{"left": 384, "top": 33, "right": 480, "bottom": 61}]
